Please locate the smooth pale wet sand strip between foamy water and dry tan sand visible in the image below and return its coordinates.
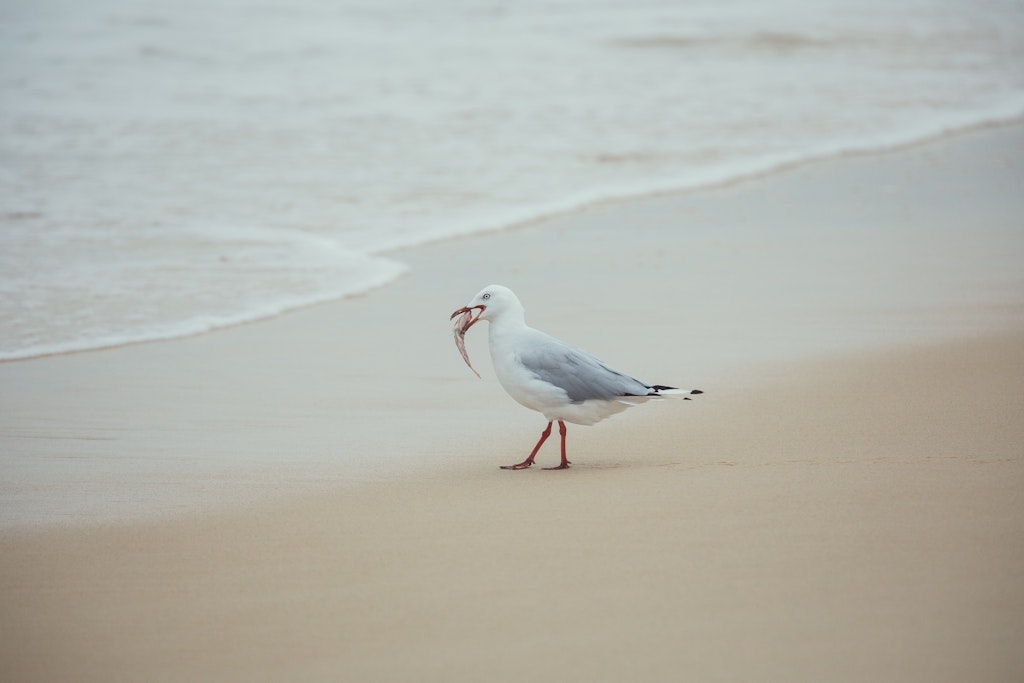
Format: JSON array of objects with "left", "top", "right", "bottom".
[{"left": 0, "top": 121, "right": 1024, "bottom": 527}]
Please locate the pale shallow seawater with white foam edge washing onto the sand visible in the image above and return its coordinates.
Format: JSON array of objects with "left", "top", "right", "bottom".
[{"left": 0, "top": 0, "right": 1024, "bottom": 359}]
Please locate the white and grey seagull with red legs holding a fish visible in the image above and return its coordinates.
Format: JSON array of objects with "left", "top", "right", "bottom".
[{"left": 450, "top": 285, "right": 703, "bottom": 470}]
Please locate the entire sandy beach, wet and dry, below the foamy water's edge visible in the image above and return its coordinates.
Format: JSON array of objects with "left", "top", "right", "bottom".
[{"left": 0, "top": 125, "right": 1024, "bottom": 681}]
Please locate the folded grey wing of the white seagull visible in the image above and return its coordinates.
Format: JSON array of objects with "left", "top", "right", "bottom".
[{"left": 519, "top": 335, "right": 651, "bottom": 403}]
